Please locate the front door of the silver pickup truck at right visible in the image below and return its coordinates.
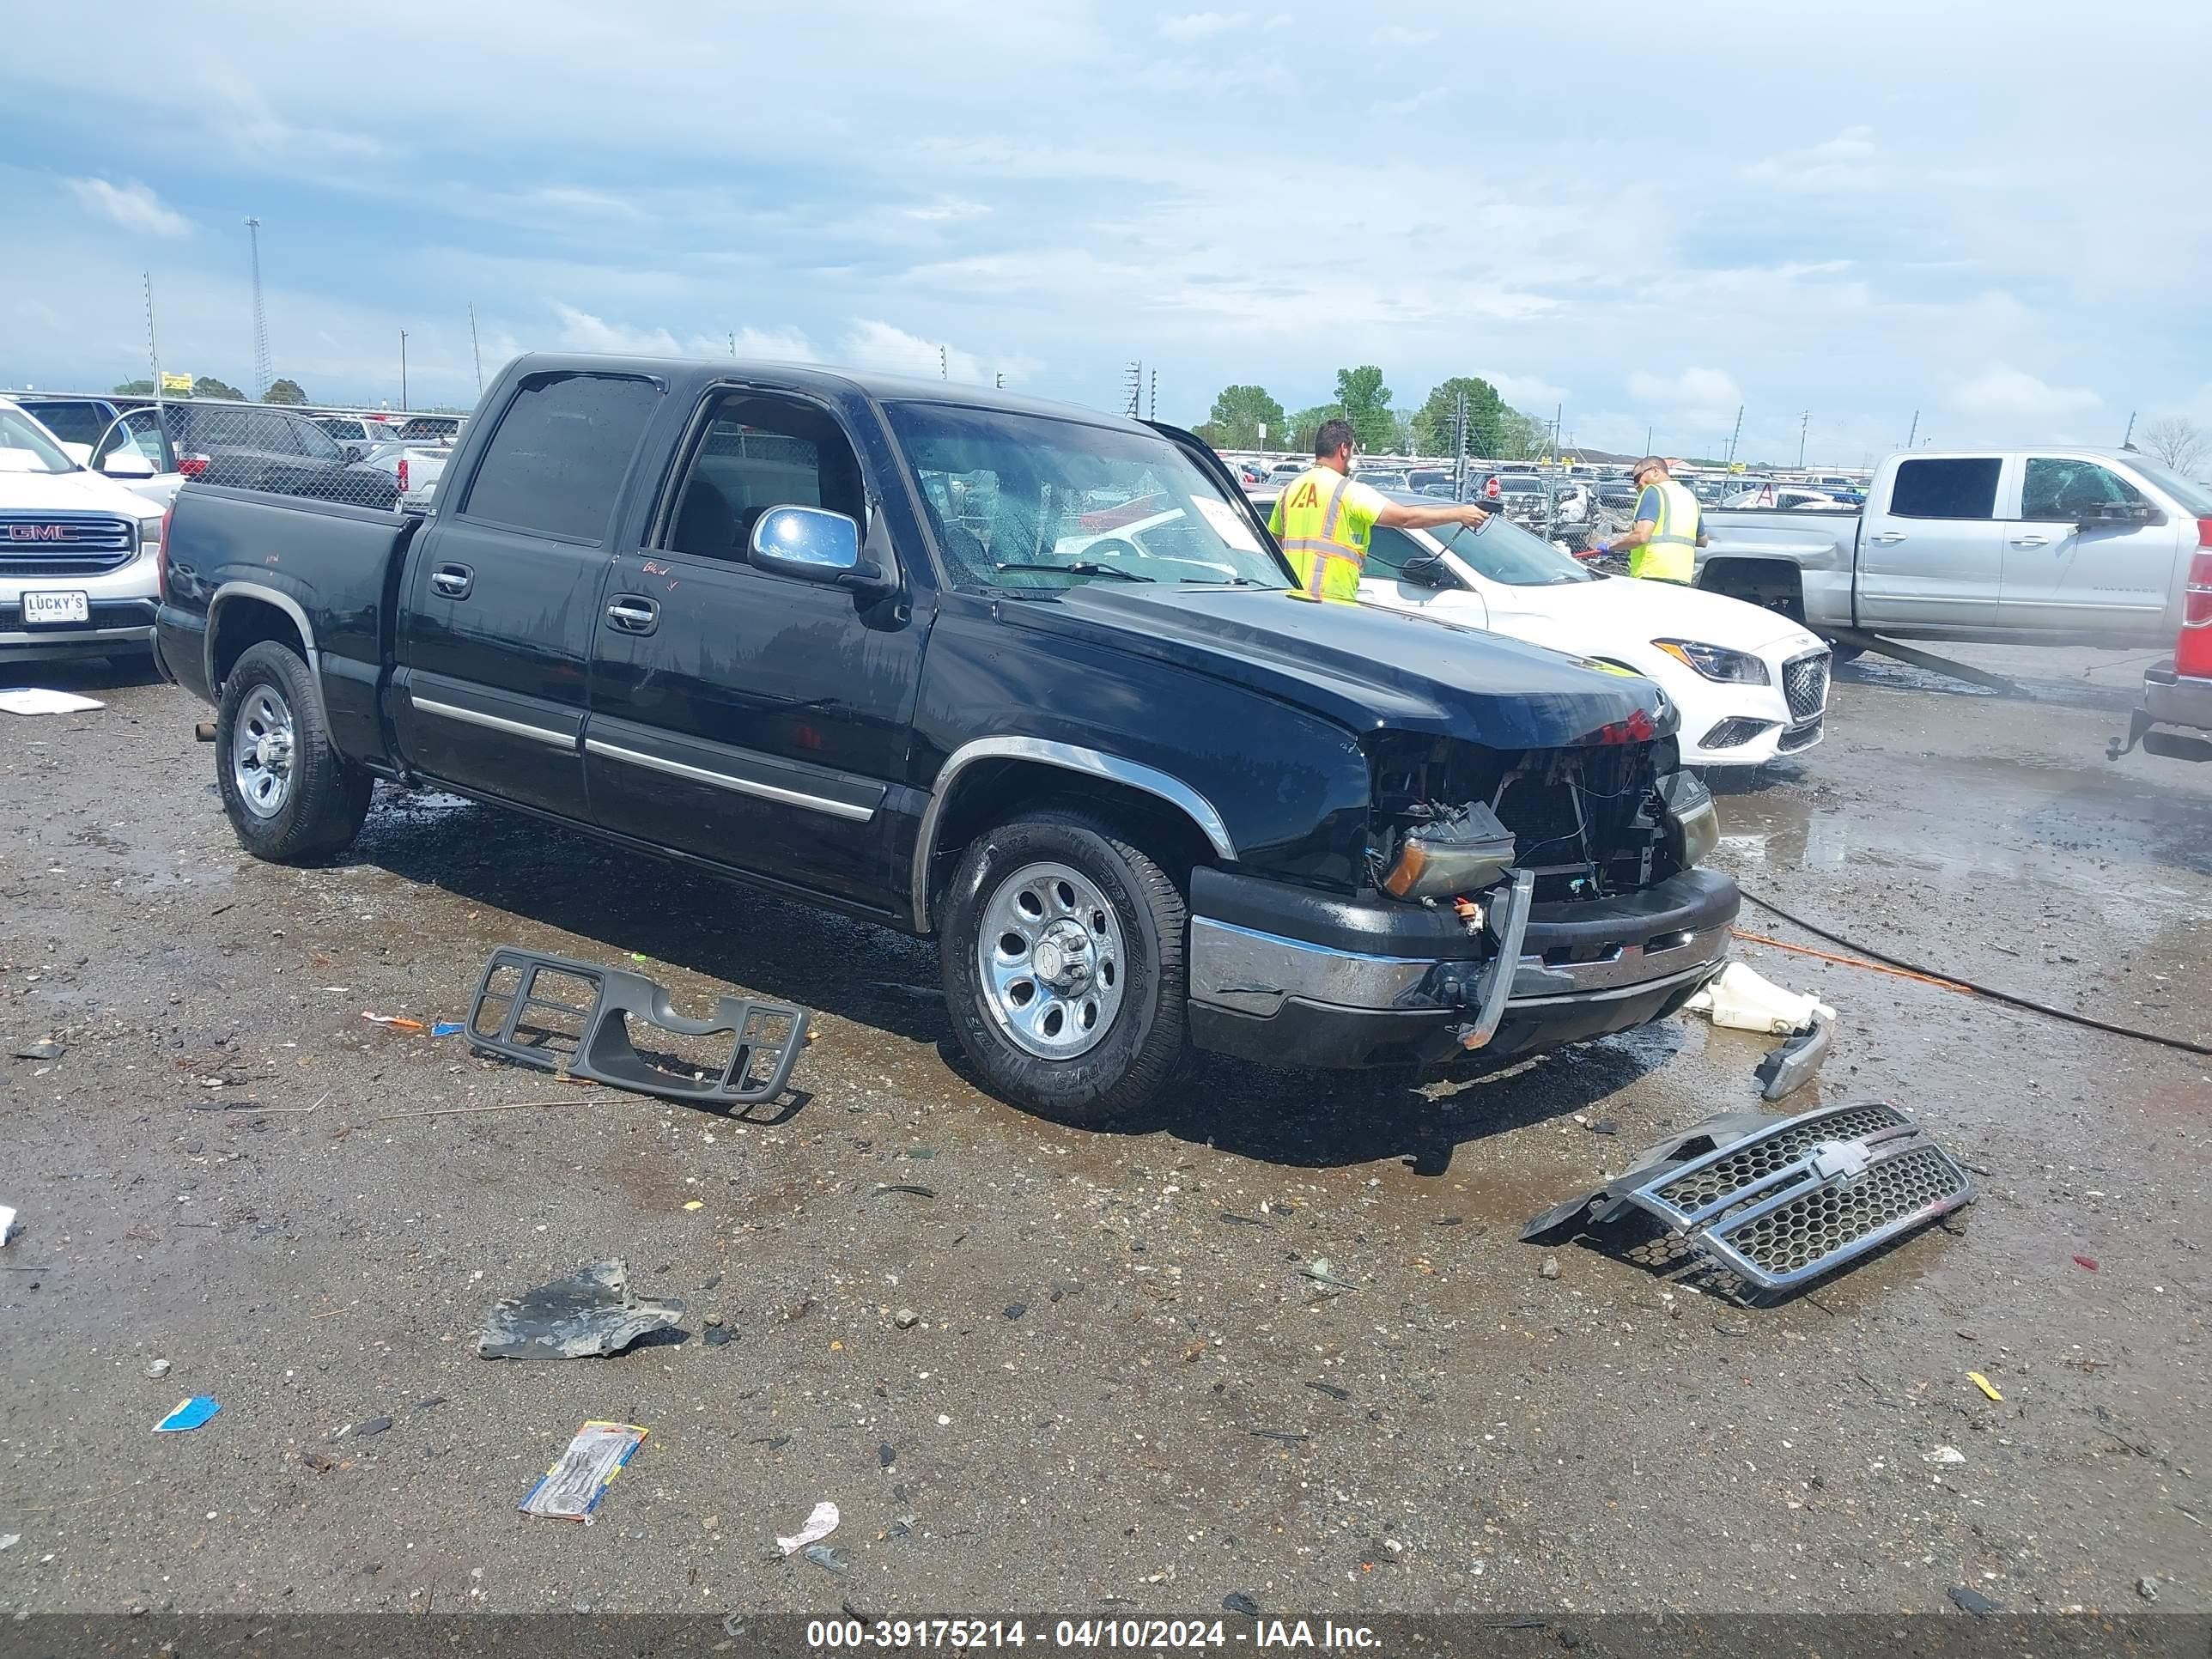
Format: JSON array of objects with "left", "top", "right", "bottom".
[{"left": 1997, "top": 453, "right": 2197, "bottom": 646}]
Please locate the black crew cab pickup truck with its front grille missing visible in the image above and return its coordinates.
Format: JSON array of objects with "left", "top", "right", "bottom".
[{"left": 157, "top": 356, "right": 1739, "bottom": 1121}]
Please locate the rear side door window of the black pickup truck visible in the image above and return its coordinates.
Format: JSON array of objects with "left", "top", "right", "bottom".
[{"left": 460, "top": 374, "right": 661, "bottom": 542}]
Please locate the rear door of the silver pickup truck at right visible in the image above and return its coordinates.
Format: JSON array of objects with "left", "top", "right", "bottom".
[{"left": 1858, "top": 456, "right": 2004, "bottom": 629}]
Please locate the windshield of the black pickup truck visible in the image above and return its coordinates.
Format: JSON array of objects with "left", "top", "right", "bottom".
[{"left": 887, "top": 403, "right": 1287, "bottom": 598}]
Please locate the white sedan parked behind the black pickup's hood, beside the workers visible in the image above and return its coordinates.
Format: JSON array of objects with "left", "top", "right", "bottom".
[{"left": 1360, "top": 515, "right": 1829, "bottom": 765}]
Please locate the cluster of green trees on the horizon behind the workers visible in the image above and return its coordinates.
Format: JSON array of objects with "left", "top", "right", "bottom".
[{"left": 1197, "top": 362, "right": 1551, "bottom": 460}]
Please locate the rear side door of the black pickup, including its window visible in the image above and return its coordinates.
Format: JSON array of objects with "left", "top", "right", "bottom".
[{"left": 389, "top": 374, "right": 661, "bottom": 818}]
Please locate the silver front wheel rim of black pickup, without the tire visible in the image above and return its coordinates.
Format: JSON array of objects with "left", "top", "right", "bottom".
[{"left": 975, "top": 863, "right": 1128, "bottom": 1060}]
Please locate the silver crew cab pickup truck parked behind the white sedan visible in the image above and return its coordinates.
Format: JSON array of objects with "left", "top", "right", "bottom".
[{"left": 1697, "top": 445, "right": 2212, "bottom": 646}]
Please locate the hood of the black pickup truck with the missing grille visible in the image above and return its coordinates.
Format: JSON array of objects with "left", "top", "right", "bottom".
[{"left": 1000, "top": 581, "right": 1659, "bottom": 750}]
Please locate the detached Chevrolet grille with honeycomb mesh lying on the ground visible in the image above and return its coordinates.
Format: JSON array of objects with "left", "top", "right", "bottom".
[{"left": 1522, "top": 1099, "right": 1975, "bottom": 1294}]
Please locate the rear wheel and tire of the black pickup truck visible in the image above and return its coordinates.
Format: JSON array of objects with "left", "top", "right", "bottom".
[{"left": 215, "top": 639, "right": 376, "bottom": 865}]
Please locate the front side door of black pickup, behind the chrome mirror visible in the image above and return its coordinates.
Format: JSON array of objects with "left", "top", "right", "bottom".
[{"left": 584, "top": 387, "right": 927, "bottom": 907}]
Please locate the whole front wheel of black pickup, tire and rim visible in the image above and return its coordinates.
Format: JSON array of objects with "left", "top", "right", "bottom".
[{"left": 938, "top": 810, "right": 1190, "bottom": 1128}]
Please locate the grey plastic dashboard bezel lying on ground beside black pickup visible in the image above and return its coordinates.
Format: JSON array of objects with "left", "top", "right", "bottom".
[{"left": 469, "top": 945, "right": 807, "bottom": 1106}]
